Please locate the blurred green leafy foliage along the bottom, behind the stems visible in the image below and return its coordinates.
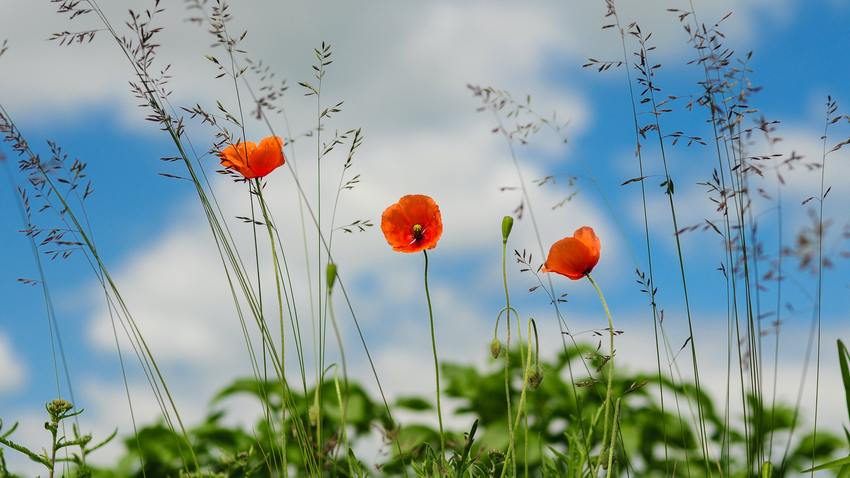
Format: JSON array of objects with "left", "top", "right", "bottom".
[{"left": 0, "top": 346, "right": 824, "bottom": 478}]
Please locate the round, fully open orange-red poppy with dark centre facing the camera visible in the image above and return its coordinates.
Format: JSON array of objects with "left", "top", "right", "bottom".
[{"left": 381, "top": 194, "right": 443, "bottom": 252}]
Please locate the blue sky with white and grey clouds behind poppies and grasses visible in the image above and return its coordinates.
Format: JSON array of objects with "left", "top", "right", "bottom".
[{"left": 0, "top": 0, "right": 850, "bottom": 472}]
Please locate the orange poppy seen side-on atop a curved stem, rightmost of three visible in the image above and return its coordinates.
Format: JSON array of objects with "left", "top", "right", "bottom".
[{"left": 542, "top": 226, "right": 602, "bottom": 280}]
